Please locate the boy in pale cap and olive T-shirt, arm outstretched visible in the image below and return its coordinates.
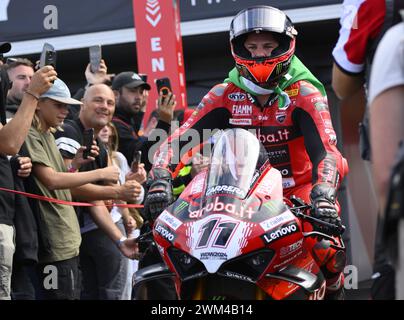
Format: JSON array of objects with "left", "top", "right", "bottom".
[{"left": 26, "top": 79, "right": 118, "bottom": 300}]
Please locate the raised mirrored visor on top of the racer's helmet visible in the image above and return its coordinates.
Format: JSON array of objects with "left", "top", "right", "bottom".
[{"left": 230, "top": 6, "right": 294, "bottom": 40}]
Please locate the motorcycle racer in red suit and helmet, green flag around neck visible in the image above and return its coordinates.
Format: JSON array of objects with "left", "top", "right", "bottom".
[{"left": 145, "top": 6, "right": 348, "bottom": 297}]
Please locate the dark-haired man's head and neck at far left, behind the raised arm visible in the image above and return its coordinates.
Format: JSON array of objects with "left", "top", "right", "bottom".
[{"left": 6, "top": 58, "right": 34, "bottom": 119}]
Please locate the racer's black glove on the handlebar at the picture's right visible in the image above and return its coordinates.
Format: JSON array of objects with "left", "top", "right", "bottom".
[{"left": 310, "top": 184, "right": 343, "bottom": 236}]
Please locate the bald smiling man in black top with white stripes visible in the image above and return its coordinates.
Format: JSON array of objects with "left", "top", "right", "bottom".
[{"left": 55, "top": 84, "right": 142, "bottom": 300}]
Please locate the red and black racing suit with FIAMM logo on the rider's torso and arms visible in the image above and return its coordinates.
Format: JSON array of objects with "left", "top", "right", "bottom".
[{"left": 154, "top": 81, "right": 348, "bottom": 292}]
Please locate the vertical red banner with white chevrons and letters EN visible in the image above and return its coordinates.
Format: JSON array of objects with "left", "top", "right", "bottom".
[{"left": 133, "top": 0, "right": 187, "bottom": 124}]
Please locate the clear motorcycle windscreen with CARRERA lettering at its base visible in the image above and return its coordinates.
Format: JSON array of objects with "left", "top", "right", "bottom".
[{"left": 206, "top": 129, "right": 261, "bottom": 199}]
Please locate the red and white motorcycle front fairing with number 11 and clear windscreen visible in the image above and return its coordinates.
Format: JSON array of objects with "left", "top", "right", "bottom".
[{"left": 153, "top": 129, "right": 324, "bottom": 298}]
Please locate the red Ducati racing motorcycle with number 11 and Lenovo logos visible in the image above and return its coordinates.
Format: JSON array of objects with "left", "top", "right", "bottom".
[{"left": 133, "top": 129, "right": 345, "bottom": 300}]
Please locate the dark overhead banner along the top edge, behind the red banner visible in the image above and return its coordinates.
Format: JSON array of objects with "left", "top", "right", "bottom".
[{"left": 0, "top": 0, "right": 342, "bottom": 42}]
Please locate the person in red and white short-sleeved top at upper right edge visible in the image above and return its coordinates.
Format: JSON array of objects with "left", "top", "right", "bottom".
[{"left": 332, "top": 0, "right": 403, "bottom": 299}]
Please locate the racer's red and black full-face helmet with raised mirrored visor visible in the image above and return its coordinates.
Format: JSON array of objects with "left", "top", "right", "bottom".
[{"left": 230, "top": 6, "right": 297, "bottom": 88}]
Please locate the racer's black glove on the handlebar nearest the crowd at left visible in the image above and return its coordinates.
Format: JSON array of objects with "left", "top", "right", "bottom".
[{"left": 144, "top": 168, "right": 174, "bottom": 222}]
